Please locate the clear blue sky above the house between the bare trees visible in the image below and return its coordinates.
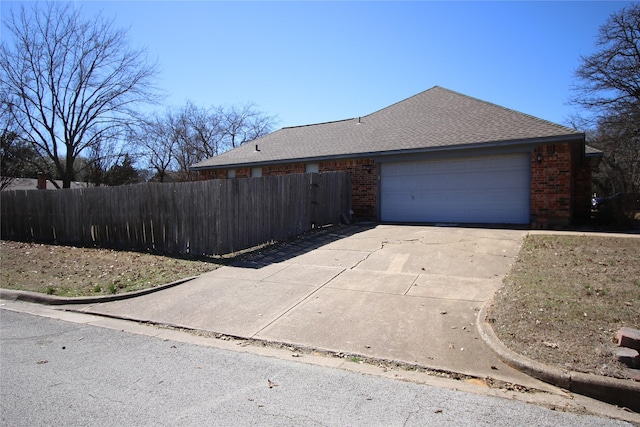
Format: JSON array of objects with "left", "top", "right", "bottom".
[{"left": 1, "top": 0, "right": 629, "bottom": 128}]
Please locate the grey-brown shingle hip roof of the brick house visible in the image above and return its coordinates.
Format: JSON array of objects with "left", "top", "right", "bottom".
[{"left": 193, "top": 86, "right": 584, "bottom": 169}]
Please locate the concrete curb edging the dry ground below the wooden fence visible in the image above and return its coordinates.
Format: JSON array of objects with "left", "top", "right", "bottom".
[{"left": 0, "top": 276, "right": 197, "bottom": 305}]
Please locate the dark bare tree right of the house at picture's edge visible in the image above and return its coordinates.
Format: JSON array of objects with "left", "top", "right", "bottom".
[{"left": 571, "top": 3, "right": 640, "bottom": 194}]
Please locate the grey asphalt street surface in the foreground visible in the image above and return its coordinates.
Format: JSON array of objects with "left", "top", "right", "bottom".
[{"left": 0, "top": 309, "right": 630, "bottom": 426}]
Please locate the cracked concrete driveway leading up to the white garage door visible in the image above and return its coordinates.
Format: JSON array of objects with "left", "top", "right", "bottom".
[{"left": 74, "top": 225, "right": 542, "bottom": 386}]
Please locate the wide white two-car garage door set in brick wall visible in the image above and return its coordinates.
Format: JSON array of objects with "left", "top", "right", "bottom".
[{"left": 380, "top": 153, "right": 530, "bottom": 224}]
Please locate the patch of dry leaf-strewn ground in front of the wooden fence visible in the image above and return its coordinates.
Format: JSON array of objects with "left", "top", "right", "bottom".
[{"left": 0, "top": 240, "right": 220, "bottom": 297}]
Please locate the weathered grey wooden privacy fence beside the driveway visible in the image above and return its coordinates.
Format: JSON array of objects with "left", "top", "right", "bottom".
[{"left": 0, "top": 172, "right": 351, "bottom": 255}]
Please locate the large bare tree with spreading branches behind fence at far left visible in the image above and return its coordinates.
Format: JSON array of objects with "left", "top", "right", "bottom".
[{"left": 0, "top": 2, "right": 156, "bottom": 188}]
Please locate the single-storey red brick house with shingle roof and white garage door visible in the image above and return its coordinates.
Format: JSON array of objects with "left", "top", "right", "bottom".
[{"left": 192, "top": 86, "right": 599, "bottom": 228}]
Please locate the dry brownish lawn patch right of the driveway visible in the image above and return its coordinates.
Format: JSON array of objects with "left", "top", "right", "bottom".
[{"left": 488, "top": 235, "right": 640, "bottom": 378}]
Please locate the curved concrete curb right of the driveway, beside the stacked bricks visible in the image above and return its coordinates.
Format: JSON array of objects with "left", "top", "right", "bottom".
[{"left": 477, "top": 301, "right": 640, "bottom": 412}]
